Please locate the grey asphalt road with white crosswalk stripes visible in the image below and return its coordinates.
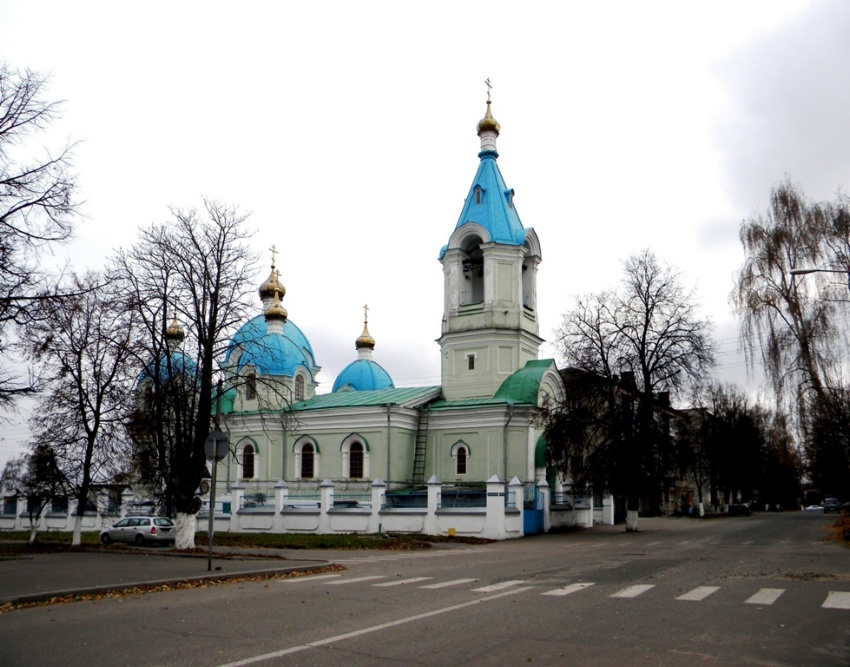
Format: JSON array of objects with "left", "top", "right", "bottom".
[{"left": 0, "top": 512, "right": 850, "bottom": 667}]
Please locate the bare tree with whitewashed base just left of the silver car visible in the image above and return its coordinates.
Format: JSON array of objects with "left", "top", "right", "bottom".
[{"left": 27, "top": 273, "right": 137, "bottom": 545}]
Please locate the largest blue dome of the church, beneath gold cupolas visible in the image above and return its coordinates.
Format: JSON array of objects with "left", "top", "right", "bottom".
[{"left": 225, "top": 315, "right": 316, "bottom": 376}]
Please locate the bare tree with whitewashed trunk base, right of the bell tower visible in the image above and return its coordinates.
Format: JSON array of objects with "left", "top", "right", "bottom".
[{"left": 557, "top": 251, "right": 714, "bottom": 530}]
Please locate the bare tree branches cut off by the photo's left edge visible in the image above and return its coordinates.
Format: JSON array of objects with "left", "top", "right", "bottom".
[{"left": 0, "top": 63, "right": 77, "bottom": 407}]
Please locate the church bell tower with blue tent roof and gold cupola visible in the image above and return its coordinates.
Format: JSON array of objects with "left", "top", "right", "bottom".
[{"left": 437, "top": 94, "right": 543, "bottom": 400}]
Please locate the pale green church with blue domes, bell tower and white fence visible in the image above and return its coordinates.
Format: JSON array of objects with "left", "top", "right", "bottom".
[{"left": 206, "top": 95, "right": 580, "bottom": 537}]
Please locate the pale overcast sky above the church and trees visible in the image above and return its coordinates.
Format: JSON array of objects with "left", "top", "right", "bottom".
[{"left": 0, "top": 0, "right": 850, "bottom": 464}]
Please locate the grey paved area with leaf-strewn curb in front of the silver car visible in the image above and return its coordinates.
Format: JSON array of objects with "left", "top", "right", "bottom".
[{"left": 0, "top": 547, "right": 331, "bottom": 605}]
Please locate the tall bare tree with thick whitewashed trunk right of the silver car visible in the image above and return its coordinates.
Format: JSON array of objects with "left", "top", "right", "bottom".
[{"left": 117, "top": 200, "right": 256, "bottom": 548}]
